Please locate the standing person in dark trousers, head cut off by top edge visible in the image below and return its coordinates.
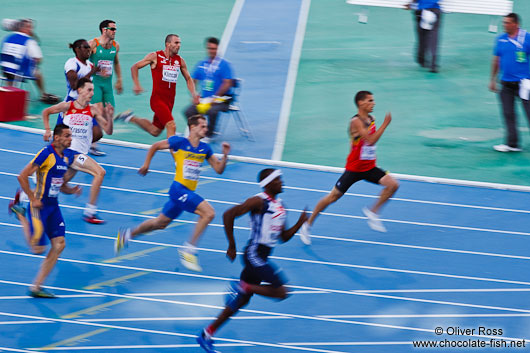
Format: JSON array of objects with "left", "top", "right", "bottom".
[{"left": 406, "top": 0, "right": 442, "bottom": 72}]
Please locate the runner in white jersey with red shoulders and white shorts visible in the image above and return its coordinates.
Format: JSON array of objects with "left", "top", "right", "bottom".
[{"left": 42, "top": 77, "right": 114, "bottom": 224}]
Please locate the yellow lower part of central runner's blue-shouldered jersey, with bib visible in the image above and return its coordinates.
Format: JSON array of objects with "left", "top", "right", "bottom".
[{"left": 171, "top": 150, "right": 206, "bottom": 191}]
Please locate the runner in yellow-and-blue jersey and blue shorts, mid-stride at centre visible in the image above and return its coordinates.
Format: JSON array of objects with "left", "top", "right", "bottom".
[{"left": 115, "top": 115, "right": 230, "bottom": 271}]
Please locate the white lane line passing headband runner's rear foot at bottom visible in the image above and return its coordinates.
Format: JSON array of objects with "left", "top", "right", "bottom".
[{"left": 0, "top": 312, "right": 346, "bottom": 353}]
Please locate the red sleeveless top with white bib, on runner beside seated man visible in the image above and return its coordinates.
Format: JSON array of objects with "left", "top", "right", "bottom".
[{"left": 151, "top": 50, "right": 182, "bottom": 99}]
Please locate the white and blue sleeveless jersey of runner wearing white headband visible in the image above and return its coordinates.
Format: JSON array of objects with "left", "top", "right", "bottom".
[{"left": 246, "top": 192, "right": 287, "bottom": 266}]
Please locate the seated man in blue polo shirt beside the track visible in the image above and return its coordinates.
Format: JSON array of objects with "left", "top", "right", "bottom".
[{"left": 184, "top": 37, "right": 234, "bottom": 138}]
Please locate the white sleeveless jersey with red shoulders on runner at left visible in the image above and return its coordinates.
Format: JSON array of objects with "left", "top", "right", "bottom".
[{"left": 63, "top": 102, "right": 94, "bottom": 154}]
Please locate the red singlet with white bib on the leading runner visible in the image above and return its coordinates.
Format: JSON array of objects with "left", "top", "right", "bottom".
[{"left": 345, "top": 115, "right": 376, "bottom": 172}]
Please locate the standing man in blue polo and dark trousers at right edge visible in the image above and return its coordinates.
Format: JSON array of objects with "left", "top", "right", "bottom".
[{"left": 489, "top": 13, "right": 530, "bottom": 152}]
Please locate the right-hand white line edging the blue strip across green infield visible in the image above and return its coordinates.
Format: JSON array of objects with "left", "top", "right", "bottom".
[{"left": 271, "top": 0, "right": 311, "bottom": 161}]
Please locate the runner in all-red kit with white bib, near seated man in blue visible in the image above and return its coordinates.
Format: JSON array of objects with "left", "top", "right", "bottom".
[{"left": 116, "top": 34, "right": 199, "bottom": 138}]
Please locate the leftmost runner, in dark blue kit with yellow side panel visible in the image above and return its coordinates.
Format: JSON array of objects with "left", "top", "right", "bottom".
[{"left": 9, "top": 124, "right": 81, "bottom": 298}]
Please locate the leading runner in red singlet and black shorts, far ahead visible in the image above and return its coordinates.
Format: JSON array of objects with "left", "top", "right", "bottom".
[{"left": 300, "top": 91, "right": 399, "bottom": 244}]
